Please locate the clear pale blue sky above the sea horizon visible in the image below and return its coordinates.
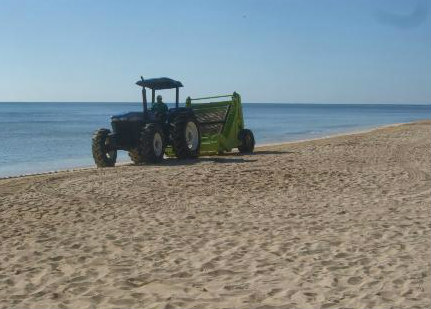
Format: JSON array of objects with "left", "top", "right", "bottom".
[{"left": 0, "top": 0, "right": 431, "bottom": 104}]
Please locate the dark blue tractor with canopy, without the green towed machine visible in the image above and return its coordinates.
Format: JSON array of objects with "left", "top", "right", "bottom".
[{"left": 92, "top": 77, "right": 200, "bottom": 167}]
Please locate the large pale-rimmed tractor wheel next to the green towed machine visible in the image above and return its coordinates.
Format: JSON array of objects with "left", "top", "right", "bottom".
[{"left": 172, "top": 115, "right": 201, "bottom": 159}]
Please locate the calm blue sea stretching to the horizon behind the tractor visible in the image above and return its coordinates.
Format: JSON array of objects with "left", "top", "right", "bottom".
[{"left": 0, "top": 103, "right": 431, "bottom": 177}]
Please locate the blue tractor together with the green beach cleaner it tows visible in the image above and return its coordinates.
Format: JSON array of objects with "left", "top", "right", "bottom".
[{"left": 92, "top": 77, "right": 255, "bottom": 167}]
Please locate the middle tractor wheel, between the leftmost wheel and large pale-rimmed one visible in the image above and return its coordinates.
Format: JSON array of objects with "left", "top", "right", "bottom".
[{"left": 129, "top": 123, "right": 166, "bottom": 164}]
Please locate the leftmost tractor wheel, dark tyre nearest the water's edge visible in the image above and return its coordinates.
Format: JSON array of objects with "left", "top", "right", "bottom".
[{"left": 91, "top": 129, "right": 117, "bottom": 167}]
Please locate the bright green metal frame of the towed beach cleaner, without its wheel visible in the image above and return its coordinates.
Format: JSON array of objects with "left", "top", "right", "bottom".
[{"left": 186, "top": 92, "right": 244, "bottom": 155}]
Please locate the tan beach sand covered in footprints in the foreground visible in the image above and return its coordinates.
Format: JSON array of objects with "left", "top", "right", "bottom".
[{"left": 0, "top": 121, "right": 431, "bottom": 308}]
